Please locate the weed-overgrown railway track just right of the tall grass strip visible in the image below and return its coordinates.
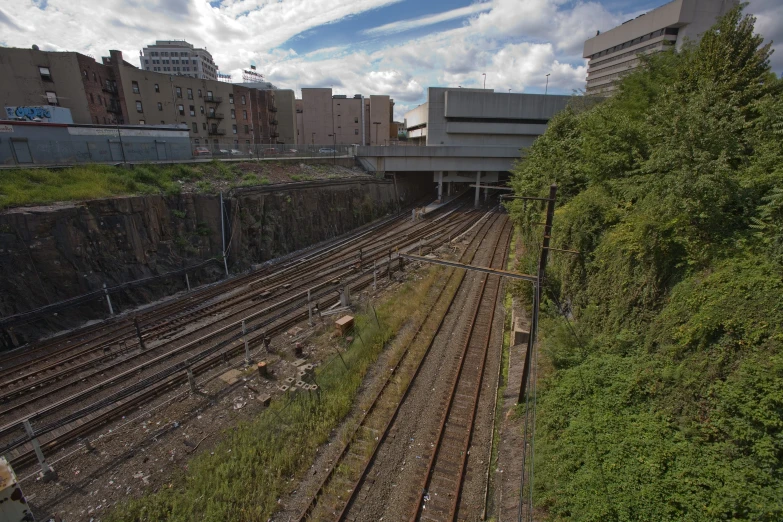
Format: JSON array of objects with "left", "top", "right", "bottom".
[{"left": 290, "top": 208, "right": 510, "bottom": 522}]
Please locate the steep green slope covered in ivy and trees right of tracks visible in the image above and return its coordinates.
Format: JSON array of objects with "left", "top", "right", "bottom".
[{"left": 511, "top": 8, "right": 783, "bottom": 521}]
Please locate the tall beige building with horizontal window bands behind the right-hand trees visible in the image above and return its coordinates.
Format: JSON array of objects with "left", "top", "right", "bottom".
[{"left": 582, "top": 0, "right": 738, "bottom": 95}]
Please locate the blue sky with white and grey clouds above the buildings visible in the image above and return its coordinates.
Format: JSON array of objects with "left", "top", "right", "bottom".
[{"left": 0, "top": 0, "right": 783, "bottom": 119}]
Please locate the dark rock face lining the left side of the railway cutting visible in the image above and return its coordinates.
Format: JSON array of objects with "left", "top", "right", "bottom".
[{"left": 0, "top": 179, "right": 431, "bottom": 349}]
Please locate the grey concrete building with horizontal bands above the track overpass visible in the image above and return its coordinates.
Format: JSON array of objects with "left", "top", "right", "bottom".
[{"left": 405, "top": 87, "right": 571, "bottom": 148}]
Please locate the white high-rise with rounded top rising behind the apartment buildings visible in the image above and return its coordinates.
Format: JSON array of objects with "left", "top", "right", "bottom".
[{"left": 139, "top": 40, "right": 218, "bottom": 80}]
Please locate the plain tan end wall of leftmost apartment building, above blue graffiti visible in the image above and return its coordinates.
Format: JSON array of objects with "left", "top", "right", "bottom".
[{"left": 0, "top": 48, "right": 92, "bottom": 123}]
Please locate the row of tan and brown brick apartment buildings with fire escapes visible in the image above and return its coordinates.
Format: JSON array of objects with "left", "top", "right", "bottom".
[{"left": 0, "top": 48, "right": 296, "bottom": 148}]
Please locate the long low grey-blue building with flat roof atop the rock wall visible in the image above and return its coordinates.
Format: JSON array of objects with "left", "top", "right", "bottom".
[{"left": 0, "top": 122, "right": 192, "bottom": 165}]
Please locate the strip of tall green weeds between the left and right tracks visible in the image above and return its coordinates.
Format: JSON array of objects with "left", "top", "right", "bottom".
[{"left": 106, "top": 268, "right": 441, "bottom": 522}]
